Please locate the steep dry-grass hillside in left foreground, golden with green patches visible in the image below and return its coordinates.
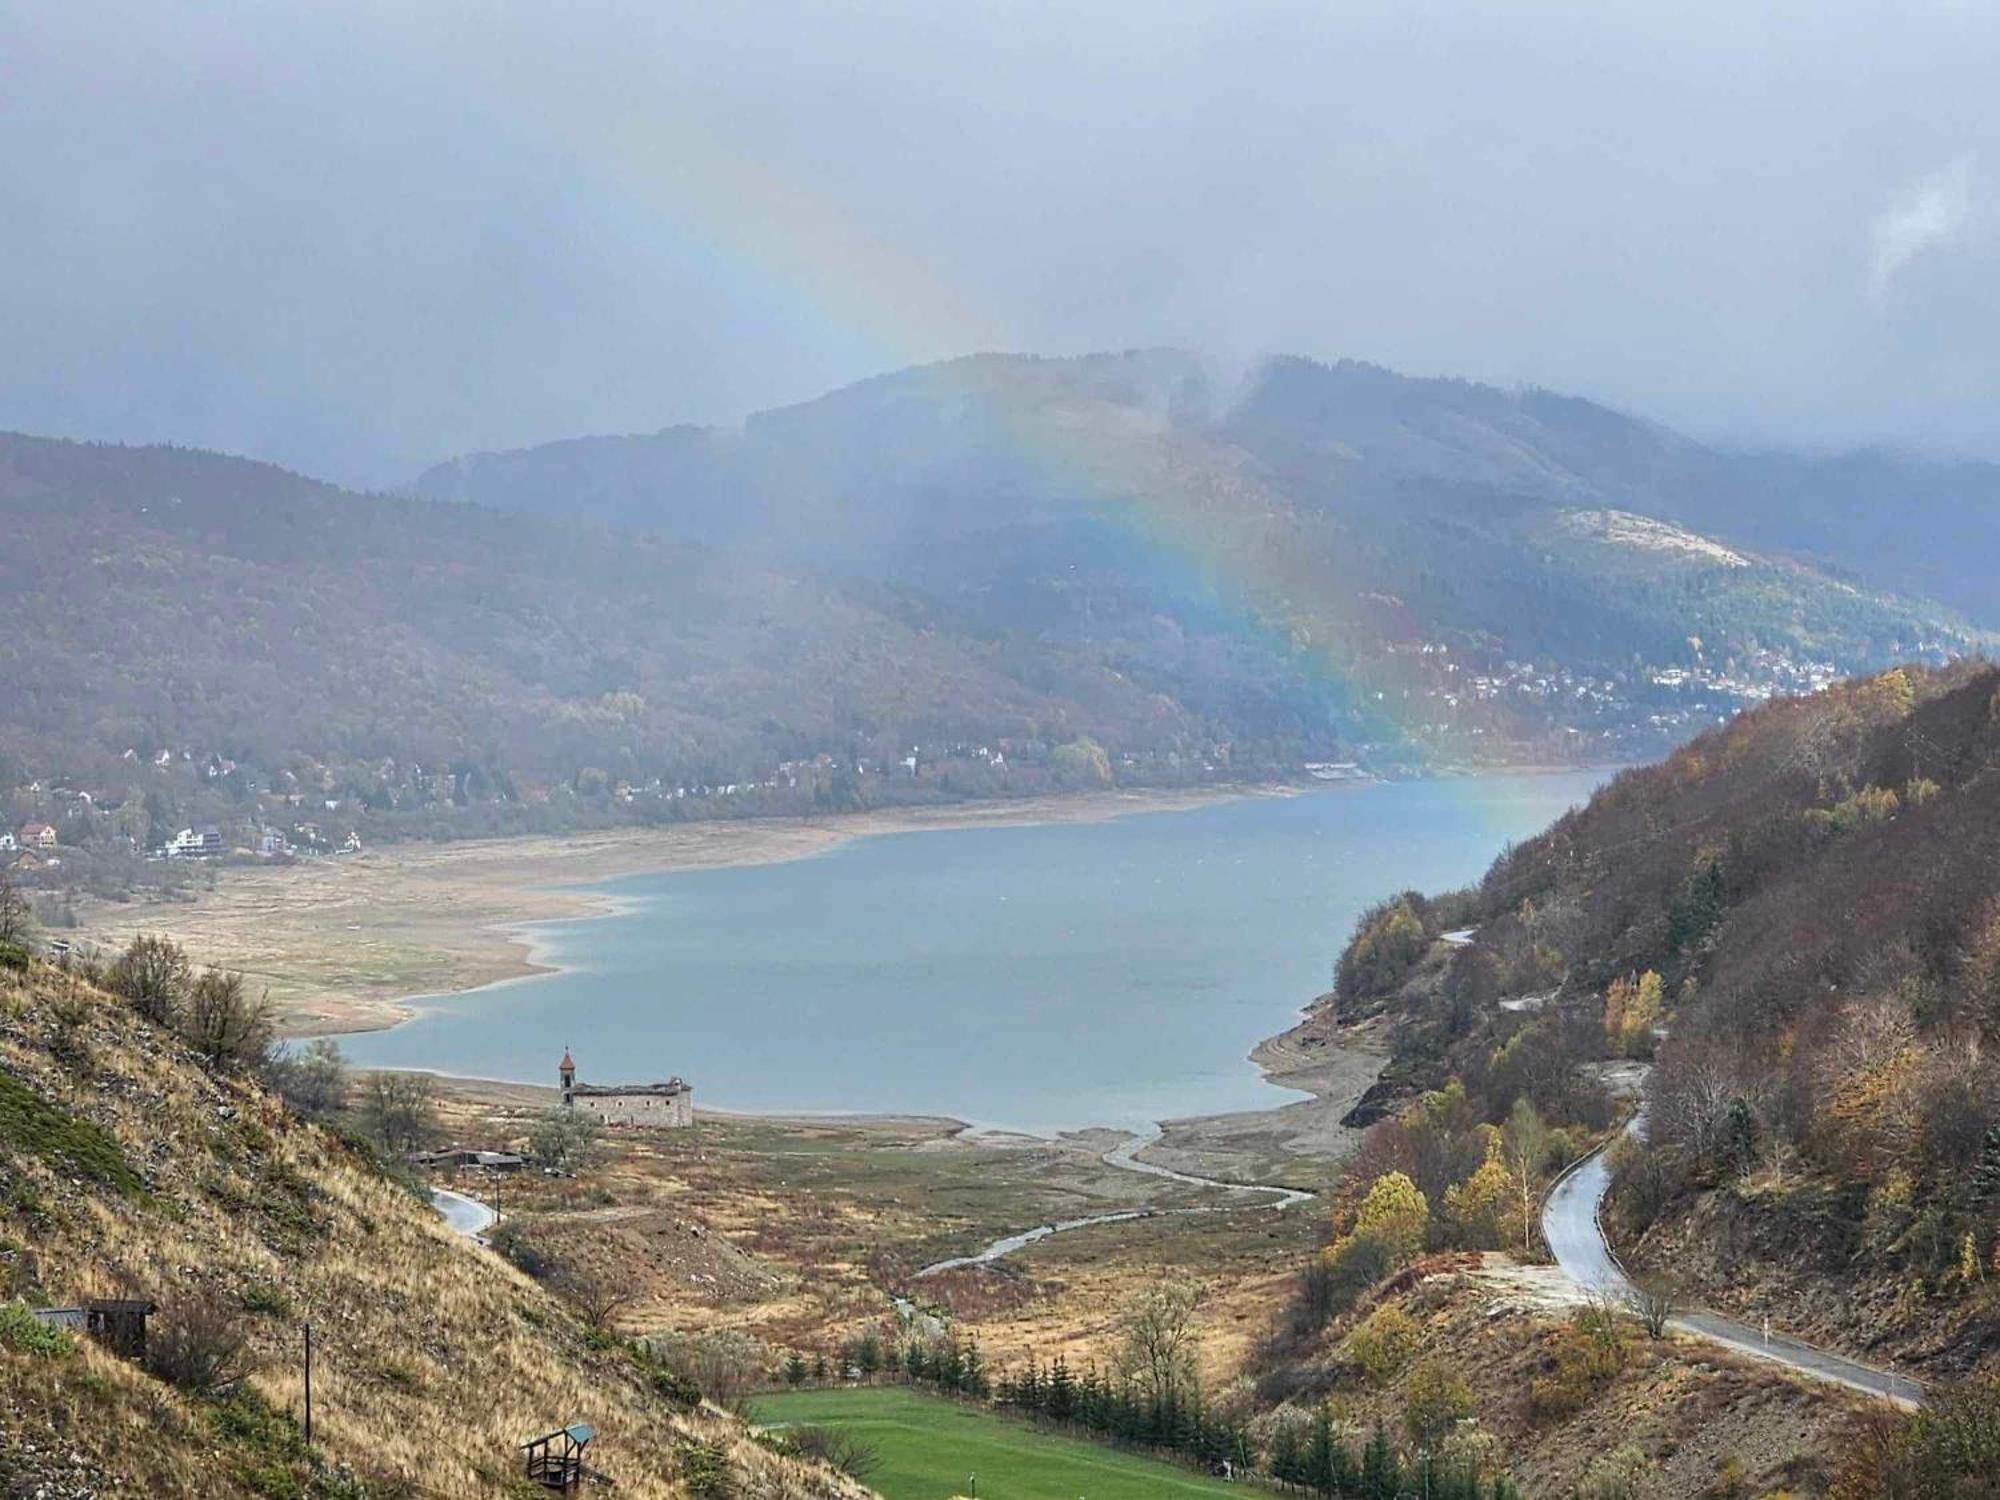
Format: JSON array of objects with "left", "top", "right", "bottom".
[{"left": 0, "top": 964, "right": 866, "bottom": 1500}]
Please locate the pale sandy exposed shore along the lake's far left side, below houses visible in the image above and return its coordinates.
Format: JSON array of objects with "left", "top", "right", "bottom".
[{"left": 76, "top": 786, "right": 1298, "bottom": 1036}]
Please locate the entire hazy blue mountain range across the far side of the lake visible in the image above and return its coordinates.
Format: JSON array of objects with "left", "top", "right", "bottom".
[{"left": 0, "top": 350, "right": 2000, "bottom": 868}]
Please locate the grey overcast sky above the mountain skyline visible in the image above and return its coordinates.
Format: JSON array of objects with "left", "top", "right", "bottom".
[{"left": 0, "top": 0, "right": 2000, "bottom": 484}]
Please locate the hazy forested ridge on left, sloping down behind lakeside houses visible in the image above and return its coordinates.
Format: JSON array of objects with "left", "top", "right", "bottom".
[{"left": 0, "top": 426, "right": 1246, "bottom": 882}]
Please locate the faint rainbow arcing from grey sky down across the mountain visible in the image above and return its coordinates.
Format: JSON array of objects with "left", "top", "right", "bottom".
[{"left": 574, "top": 104, "right": 1410, "bottom": 756}]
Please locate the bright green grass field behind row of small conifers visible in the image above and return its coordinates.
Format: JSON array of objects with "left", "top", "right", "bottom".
[{"left": 752, "top": 1386, "right": 1244, "bottom": 1500}]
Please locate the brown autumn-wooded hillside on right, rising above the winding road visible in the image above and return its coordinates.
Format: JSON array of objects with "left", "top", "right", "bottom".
[{"left": 1334, "top": 664, "right": 2000, "bottom": 1376}]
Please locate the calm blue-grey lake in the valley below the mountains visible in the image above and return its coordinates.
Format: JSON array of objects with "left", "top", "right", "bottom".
[{"left": 342, "top": 772, "right": 1604, "bottom": 1132}]
